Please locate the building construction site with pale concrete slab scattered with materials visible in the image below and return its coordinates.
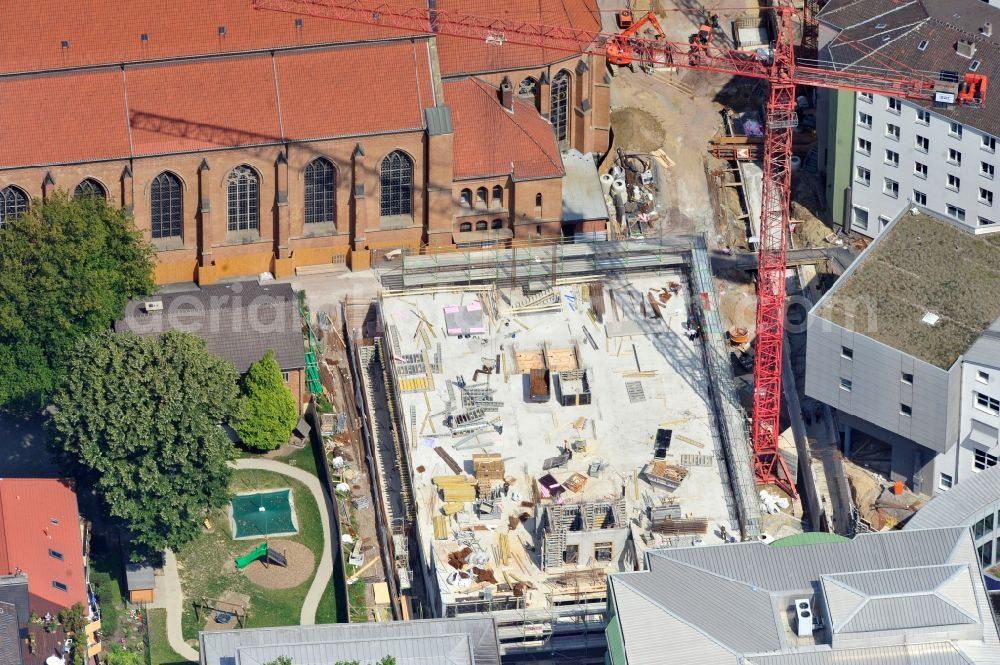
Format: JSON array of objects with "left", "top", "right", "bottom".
[{"left": 336, "top": 231, "right": 803, "bottom": 656}]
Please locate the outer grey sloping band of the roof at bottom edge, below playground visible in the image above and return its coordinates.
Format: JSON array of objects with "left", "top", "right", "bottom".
[{"left": 199, "top": 617, "right": 500, "bottom": 665}]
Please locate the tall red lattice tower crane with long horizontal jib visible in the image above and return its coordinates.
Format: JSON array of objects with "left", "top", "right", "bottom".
[{"left": 253, "top": 0, "right": 988, "bottom": 495}]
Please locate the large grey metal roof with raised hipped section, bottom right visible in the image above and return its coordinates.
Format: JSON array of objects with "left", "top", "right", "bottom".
[{"left": 611, "top": 527, "right": 1000, "bottom": 665}]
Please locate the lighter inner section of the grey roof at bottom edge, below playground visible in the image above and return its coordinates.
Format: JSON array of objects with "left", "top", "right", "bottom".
[{"left": 236, "top": 635, "right": 475, "bottom": 665}]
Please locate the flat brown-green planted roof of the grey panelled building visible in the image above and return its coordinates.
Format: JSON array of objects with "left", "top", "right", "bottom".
[{"left": 816, "top": 210, "right": 1000, "bottom": 369}]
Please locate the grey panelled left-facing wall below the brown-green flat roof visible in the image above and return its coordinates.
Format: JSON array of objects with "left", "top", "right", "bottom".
[{"left": 806, "top": 312, "right": 961, "bottom": 453}]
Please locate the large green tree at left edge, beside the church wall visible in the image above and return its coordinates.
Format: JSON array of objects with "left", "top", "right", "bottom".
[{"left": 0, "top": 193, "right": 155, "bottom": 406}]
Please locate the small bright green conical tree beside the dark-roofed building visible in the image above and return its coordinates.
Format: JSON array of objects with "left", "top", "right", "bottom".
[{"left": 236, "top": 349, "right": 299, "bottom": 450}]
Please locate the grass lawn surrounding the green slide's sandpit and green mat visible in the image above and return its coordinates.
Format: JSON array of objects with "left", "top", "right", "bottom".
[{"left": 177, "top": 470, "right": 328, "bottom": 640}]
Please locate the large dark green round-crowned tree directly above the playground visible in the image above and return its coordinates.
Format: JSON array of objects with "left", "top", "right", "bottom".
[{"left": 50, "top": 331, "right": 239, "bottom": 556}]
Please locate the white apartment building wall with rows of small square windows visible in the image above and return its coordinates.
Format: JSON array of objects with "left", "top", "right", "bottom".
[{"left": 838, "top": 93, "right": 1000, "bottom": 237}]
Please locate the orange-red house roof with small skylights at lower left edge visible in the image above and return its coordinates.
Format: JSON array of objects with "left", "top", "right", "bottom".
[{"left": 0, "top": 478, "right": 89, "bottom": 614}]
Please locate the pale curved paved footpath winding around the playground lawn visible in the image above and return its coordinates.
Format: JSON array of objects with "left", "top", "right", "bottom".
[{"left": 156, "top": 459, "right": 333, "bottom": 662}]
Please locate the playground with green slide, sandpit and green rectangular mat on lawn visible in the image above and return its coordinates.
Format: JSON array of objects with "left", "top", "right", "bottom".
[{"left": 177, "top": 469, "right": 324, "bottom": 640}]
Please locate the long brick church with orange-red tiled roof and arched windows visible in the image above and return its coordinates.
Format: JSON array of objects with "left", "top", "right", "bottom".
[{"left": 0, "top": 0, "right": 610, "bottom": 284}]
